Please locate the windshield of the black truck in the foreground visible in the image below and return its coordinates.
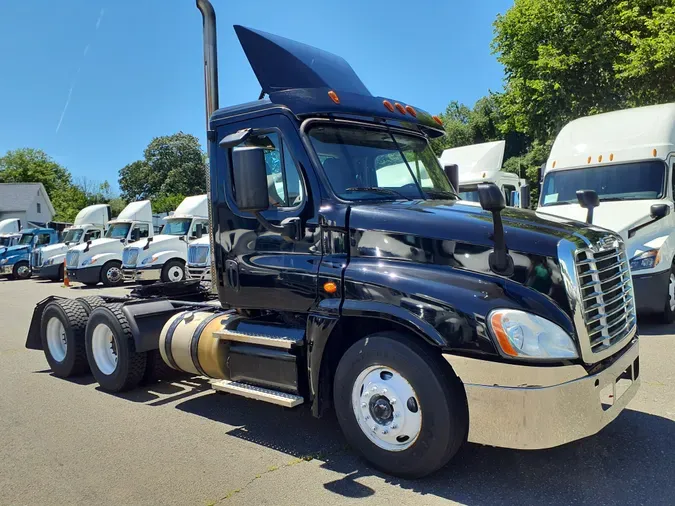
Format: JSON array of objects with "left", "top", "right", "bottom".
[{"left": 309, "top": 125, "right": 457, "bottom": 200}]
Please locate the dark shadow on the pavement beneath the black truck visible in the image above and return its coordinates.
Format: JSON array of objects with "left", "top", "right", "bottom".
[{"left": 176, "top": 393, "right": 675, "bottom": 505}]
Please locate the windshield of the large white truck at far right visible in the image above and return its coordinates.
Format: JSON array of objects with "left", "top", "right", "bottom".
[{"left": 541, "top": 160, "right": 666, "bottom": 206}]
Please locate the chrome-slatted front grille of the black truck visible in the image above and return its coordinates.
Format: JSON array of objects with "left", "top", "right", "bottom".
[{"left": 575, "top": 242, "right": 637, "bottom": 354}]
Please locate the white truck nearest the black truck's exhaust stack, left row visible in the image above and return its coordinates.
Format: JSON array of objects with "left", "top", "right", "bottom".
[{"left": 122, "top": 195, "right": 209, "bottom": 283}]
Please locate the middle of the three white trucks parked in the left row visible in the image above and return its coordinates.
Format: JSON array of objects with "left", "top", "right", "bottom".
[{"left": 66, "top": 200, "right": 154, "bottom": 286}]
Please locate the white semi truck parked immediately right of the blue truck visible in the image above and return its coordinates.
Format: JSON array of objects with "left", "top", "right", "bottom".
[{"left": 31, "top": 204, "right": 110, "bottom": 281}]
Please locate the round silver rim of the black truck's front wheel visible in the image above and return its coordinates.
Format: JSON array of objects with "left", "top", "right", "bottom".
[{"left": 352, "top": 365, "right": 422, "bottom": 452}]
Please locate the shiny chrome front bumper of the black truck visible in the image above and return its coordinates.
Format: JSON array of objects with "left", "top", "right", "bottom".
[{"left": 443, "top": 339, "right": 640, "bottom": 450}]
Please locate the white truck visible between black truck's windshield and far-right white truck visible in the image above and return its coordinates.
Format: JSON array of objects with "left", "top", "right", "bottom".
[{"left": 440, "top": 141, "right": 529, "bottom": 207}]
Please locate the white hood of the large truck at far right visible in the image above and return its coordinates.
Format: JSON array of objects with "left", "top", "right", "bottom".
[{"left": 537, "top": 200, "right": 663, "bottom": 241}]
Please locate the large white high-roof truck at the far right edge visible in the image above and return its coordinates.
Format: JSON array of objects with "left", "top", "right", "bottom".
[{"left": 537, "top": 103, "right": 675, "bottom": 322}]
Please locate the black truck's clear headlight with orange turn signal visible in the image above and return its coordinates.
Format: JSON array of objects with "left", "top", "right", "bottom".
[{"left": 487, "top": 309, "right": 579, "bottom": 359}]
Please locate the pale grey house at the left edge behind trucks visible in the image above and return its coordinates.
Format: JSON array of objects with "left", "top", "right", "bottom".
[{"left": 0, "top": 183, "right": 56, "bottom": 228}]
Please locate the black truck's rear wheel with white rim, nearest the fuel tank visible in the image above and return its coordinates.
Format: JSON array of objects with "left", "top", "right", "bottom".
[{"left": 85, "top": 304, "right": 147, "bottom": 392}]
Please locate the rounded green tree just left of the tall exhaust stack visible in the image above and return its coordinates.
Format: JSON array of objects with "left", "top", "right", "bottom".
[{"left": 119, "top": 132, "right": 206, "bottom": 204}]
